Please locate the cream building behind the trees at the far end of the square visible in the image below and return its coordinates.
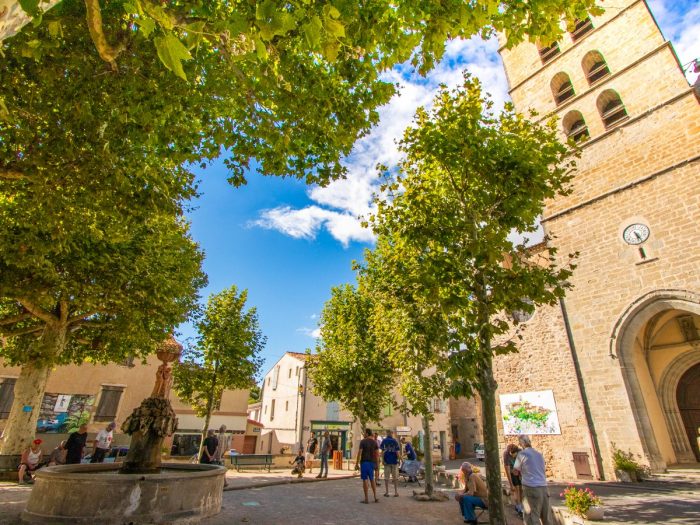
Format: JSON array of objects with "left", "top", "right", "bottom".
[{"left": 258, "top": 352, "right": 452, "bottom": 459}]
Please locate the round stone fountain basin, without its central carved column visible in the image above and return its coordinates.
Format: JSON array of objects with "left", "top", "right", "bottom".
[{"left": 22, "top": 463, "right": 226, "bottom": 525}]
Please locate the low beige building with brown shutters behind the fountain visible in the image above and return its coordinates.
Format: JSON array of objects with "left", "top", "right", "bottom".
[{"left": 0, "top": 355, "right": 252, "bottom": 455}]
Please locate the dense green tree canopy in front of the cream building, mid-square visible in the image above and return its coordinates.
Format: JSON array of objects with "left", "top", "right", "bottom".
[{"left": 307, "top": 284, "right": 394, "bottom": 429}]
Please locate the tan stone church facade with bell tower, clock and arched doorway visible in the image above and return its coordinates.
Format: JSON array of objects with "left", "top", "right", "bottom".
[{"left": 453, "top": 0, "right": 700, "bottom": 479}]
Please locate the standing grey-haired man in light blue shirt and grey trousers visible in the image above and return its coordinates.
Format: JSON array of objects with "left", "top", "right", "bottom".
[{"left": 512, "top": 435, "right": 554, "bottom": 525}]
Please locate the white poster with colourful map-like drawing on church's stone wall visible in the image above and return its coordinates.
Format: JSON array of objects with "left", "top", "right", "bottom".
[{"left": 499, "top": 390, "right": 561, "bottom": 436}]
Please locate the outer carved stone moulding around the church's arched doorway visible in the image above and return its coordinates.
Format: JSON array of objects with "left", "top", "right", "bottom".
[{"left": 610, "top": 289, "right": 700, "bottom": 471}]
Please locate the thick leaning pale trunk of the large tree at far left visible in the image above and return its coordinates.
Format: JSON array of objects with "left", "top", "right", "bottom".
[{"left": 0, "top": 328, "right": 66, "bottom": 454}]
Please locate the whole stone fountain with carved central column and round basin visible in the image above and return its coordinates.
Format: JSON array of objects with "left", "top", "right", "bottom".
[{"left": 22, "top": 336, "right": 226, "bottom": 525}]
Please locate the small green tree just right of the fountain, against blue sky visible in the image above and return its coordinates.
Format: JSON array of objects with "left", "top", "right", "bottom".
[{"left": 173, "top": 286, "right": 266, "bottom": 441}]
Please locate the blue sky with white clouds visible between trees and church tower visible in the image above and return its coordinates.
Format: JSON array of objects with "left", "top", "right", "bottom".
[{"left": 179, "top": 0, "right": 700, "bottom": 376}]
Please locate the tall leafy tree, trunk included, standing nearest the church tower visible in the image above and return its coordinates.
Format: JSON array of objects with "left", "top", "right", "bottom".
[{"left": 373, "top": 75, "right": 574, "bottom": 524}]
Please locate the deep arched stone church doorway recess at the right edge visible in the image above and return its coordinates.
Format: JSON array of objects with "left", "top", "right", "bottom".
[{"left": 611, "top": 290, "right": 700, "bottom": 471}]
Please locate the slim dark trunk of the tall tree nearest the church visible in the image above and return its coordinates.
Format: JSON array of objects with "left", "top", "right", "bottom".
[{"left": 480, "top": 352, "right": 506, "bottom": 525}]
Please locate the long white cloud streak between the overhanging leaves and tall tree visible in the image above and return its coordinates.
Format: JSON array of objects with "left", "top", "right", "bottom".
[{"left": 253, "top": 38, "right": 507, "bottom": 246}]
